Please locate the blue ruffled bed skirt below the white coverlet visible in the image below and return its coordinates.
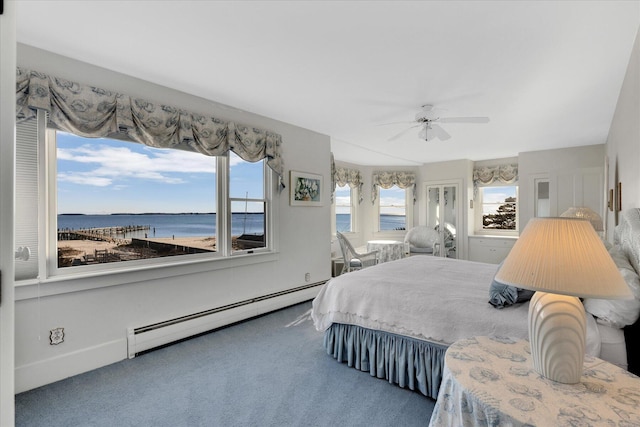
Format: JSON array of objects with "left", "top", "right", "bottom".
[{"left": 324, "top": 323, "right": 448, "bottom": 399}]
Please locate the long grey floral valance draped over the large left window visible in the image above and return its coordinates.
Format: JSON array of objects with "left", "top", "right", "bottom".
[{"left": 16, "top": 68, "right": 283, "bottom": 176}]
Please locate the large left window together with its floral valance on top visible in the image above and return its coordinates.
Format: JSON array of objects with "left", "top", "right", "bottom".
[{"left": 16, "top": 69, "right": 283, "bottom": 280}]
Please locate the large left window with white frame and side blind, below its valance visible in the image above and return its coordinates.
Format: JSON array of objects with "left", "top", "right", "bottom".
[{"left": 16, "top": 117, "right": 273, "bottom": 280}]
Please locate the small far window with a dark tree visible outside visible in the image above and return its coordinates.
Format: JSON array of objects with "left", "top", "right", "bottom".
[{"left": 479, "top": 186, "right": 518, "bottom": 232}]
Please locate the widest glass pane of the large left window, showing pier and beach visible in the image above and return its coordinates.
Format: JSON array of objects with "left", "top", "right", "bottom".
[{"left": 53, "top": 131, "right": 217, "bottom": 268}]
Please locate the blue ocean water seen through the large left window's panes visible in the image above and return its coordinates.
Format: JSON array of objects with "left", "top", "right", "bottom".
[{"left": 58, "top": 212, "right": 264, "bottom": 238}]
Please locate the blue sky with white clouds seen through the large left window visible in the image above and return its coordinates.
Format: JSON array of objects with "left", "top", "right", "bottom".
[{"left": 57, "top": 132, "right": 262, "bottom": 214}]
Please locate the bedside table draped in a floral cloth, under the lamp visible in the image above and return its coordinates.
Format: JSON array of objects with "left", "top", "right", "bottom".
[{"left": 429, "top": 337, "right": 640, "bottom": 426}]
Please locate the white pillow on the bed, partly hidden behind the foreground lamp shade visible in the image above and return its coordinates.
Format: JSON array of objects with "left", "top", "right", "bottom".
[{"left": 583, "top": 246, "right": 640, "bottom": 328}]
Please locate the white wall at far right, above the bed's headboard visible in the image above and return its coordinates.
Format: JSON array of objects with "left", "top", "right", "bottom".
[{"left": 607, "top": 26, "right": 640, "bottom": 240}]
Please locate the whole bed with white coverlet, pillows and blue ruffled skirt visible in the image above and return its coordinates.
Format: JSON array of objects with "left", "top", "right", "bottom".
[{"left": 311, "top": 209, "right": 640, "bottom": 399}]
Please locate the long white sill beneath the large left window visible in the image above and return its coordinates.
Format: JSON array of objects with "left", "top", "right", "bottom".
[{"left": 15, "top": 252, "right": 279, "bottom": 301}]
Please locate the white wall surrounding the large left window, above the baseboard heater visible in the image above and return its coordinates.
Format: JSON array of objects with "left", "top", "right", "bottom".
[{"left": 15, "top": 45, "right": 330, "bottom": 391}]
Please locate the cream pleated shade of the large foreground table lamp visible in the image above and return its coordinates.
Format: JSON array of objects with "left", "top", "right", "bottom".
[{"left": 496, "top": 218, "right": 633, "bottom": 299}]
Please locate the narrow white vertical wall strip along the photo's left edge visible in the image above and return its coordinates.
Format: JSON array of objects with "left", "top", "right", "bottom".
[{"left": 0, "top": 2, "right": 16, "bottom": 426}]
